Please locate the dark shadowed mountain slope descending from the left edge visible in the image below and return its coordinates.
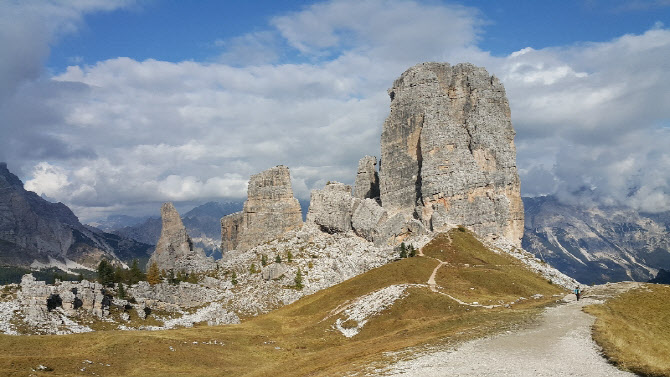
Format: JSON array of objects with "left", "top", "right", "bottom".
[{"left": 0, "top": 163, "right": 150, "bottom": 270}]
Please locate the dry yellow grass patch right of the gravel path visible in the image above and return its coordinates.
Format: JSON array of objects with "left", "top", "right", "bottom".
[{"left": 585, "top": 284, "right": 670, "bottom": 376}]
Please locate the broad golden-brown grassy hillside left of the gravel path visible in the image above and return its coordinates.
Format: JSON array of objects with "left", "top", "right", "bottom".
[{"left": 0, "top": 230, "right": 563, "bottom": 376}]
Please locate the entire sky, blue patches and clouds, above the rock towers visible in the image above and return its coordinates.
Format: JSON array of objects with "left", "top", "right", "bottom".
[{"left": 0, "top": 0, "right": 670, "bottom": 222}]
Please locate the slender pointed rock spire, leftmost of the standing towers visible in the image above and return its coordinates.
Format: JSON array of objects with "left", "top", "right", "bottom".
[{"left": 149, "top": 203, "right": 215, "bottom": 272}]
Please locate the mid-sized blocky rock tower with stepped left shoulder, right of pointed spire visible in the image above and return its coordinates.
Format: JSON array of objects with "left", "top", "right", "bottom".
[{"left": 221, "top": 165, "right": 302, "bottom": 252}]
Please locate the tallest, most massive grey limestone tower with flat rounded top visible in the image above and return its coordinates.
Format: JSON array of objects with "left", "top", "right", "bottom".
[{"left": 379, "top": 63, "right": 523, "bottom": 245}]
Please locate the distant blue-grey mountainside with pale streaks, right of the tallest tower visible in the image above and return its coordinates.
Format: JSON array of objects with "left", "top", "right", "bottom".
[{"left": 523, "top": 196, "right": 670, "bottom": 284}]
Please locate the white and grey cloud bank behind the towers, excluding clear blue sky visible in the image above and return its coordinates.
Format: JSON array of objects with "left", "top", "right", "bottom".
[{"left": 0, "top": 0, "right": 670, "bottom": 220}]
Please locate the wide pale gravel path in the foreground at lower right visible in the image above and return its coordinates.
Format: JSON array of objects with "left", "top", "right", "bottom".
[{"left": 382, "top": 283, "right": 637, "bottom": 376}]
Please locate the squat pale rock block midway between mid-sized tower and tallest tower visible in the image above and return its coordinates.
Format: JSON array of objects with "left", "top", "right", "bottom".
[{"left": 306, "top": 182, "right": 355, "bottom": 233}]
